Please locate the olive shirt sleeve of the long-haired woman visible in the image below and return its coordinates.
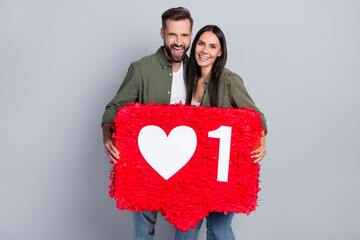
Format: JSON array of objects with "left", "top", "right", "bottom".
[{"left": 227, "top": 73, "right": 267, "bottom": 132}]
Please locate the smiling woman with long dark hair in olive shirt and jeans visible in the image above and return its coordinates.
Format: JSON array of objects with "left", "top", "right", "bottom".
[{"left": 175, "top": 25, "right": 266, "bottom": 240}]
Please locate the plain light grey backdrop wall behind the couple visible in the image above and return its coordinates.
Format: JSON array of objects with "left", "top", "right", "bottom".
[{"left": 0, "top": 0, "right": 360, "bottom": 240}]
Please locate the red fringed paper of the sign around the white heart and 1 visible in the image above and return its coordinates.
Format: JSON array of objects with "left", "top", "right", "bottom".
[{"left": 109, "top": 103, "right": 264, "bottom": 231}]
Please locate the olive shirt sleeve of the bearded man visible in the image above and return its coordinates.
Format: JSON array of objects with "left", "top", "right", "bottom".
[{"left": 101, "top": 63, "right": 141, "bottom": 125}]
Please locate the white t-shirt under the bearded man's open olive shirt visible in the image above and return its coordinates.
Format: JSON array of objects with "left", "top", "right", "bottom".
[{"left": 170, "top": 63, "right": 186, "bottom": 104}]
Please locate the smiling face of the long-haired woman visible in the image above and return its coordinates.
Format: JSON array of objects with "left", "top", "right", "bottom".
[{"left": 195, "top": 31, "right": 222, "bottom": 68}]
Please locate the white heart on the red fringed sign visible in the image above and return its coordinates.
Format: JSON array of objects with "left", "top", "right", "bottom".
[{"left": 138, "top": 125, "right": 197, "bottom": 180}]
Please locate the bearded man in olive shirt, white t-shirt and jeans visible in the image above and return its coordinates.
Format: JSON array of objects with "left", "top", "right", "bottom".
[{"left": 102, "top": 7, "right": 193, "bottom": 240}]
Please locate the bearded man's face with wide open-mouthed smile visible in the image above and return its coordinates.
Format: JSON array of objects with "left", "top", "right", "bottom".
[{"left": 161, "top": 19, "right": 192, "bottom": 63}]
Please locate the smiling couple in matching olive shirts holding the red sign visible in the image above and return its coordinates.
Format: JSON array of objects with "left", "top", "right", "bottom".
[{"left": 102, "top": 7, "right": 266, "bottom": 240}]
